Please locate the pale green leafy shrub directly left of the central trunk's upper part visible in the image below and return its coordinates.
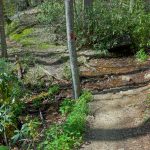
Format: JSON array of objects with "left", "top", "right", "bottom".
[{"left": 37, "top": 0, "right": 66, "bottom": 39}]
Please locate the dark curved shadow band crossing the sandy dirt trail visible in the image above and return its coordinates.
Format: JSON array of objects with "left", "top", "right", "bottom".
[{"left": 88, "top": 118, "right": 150, "bottom": 141}]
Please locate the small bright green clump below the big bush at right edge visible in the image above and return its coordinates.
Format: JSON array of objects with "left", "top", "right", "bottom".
[{"left": 135, "top": 49, "right": 148, "bottom": 61}]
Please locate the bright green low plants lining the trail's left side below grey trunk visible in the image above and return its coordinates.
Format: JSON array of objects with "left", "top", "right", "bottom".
[{"left": 39, "top": 92, "right": 92, "bottom": 150}]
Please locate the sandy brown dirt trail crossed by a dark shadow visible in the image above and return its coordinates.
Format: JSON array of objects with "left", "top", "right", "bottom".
[{"left": 81, "top": 85, "right": 150, "bottom": 150}]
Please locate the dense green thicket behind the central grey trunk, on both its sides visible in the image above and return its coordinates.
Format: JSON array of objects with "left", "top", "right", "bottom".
[{"left": 39, "top": 0, "right": 150, "bottom": 53}]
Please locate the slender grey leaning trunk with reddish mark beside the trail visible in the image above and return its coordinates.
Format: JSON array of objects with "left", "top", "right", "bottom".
[{"left": 65, "top": 0, "right": 80, "bottom": 99}]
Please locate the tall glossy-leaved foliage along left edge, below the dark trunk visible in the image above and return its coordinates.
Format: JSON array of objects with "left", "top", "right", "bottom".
[{"left": 0, "top": 60, "right": 23, "bottom": 144}]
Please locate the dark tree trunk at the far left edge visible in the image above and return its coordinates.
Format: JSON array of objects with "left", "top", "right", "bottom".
[{"left": 0, "top": 0, "right": 7, "bottom": 58}]
